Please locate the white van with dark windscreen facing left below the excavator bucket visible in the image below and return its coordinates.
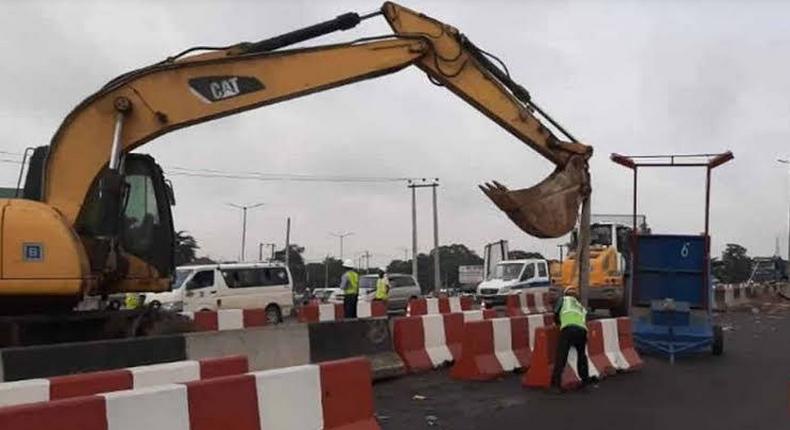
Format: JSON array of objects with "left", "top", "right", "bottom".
[{"left": 477, "top": 258, "right": 551, "bottom": 306}]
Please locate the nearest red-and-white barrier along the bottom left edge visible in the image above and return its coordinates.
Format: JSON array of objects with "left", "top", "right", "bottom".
[{"left": 0, "top": 358, "right": 380, "bottom": 430}]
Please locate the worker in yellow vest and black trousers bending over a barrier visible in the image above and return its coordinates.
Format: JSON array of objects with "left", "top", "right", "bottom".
[{"left": 551, "top": 287, "right": 593, "bottom": 391}]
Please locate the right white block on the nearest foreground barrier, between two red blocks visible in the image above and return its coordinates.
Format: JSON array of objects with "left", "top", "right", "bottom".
[{"left": 256, "top": 364, "right": 324, "bottom": 430}]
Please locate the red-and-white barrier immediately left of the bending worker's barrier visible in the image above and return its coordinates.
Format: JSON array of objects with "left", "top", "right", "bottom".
[{"left": 450, "top": 317, "right": 531, "bottom": 380}]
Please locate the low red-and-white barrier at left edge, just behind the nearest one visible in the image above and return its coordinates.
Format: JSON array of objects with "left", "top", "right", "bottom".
[{"left": 0, "top": 355, "right": 249, "bottom": 408}]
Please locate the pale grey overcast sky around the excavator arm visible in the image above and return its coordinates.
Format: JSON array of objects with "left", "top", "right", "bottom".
[{"left": 0, "top": 0, "right": 790, "bottom": 264}]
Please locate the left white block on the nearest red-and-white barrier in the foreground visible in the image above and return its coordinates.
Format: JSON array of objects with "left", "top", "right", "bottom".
[{"left": 102, "top": 385, "right": 189, "bottom": 430}]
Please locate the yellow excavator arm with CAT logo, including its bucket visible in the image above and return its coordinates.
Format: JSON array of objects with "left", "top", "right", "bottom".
[{"left": 12, "top": 2, "right": 592, "bottom": 302}]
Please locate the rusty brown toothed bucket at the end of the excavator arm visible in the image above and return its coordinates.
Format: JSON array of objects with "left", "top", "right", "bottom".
[{"left": 480, "top": 156, "right": 590, "bottom": 238}]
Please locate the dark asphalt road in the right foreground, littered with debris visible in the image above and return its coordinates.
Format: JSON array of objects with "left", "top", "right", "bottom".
[{"left": 374, "top": 302, "right": 790, "bottom": 430}]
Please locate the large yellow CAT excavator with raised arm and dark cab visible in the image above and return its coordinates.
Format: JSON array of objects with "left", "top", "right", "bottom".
[{"left": 0, "top": 2, "right": 592, "bottom": 314}]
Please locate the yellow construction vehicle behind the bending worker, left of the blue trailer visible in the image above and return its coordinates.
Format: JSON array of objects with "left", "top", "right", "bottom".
[{"left": 551, "top": 214, "right": 650, "bottom": 316}]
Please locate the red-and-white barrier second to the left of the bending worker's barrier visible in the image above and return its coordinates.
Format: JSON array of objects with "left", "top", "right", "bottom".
[{"left": 393, "top": 313, "right": 464, "bottom": 372}]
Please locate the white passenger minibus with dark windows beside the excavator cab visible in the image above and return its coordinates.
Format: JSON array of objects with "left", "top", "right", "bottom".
[{"left": 145, "top": 262, "right": 293, "bottom": 322}]
